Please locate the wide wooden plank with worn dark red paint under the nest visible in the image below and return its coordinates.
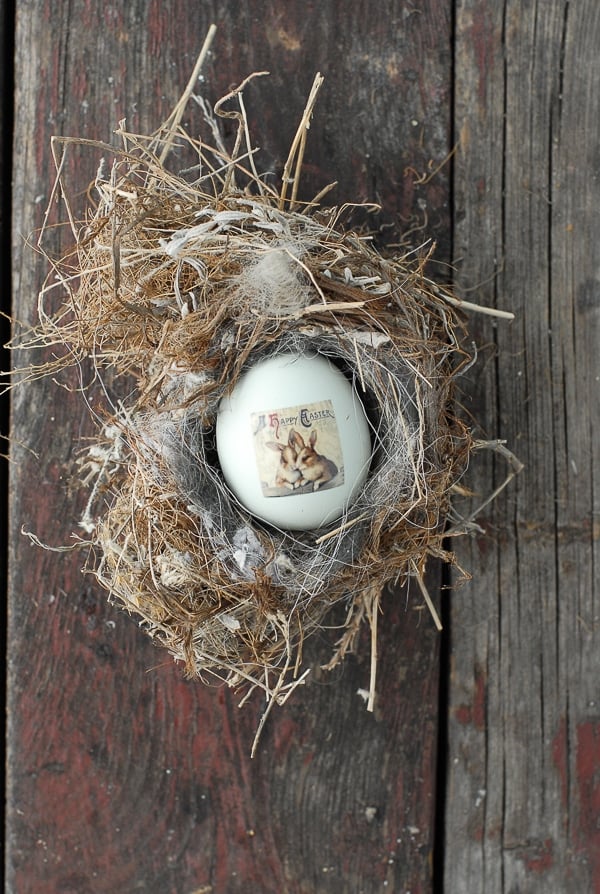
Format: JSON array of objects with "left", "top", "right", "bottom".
[{"left": 7, "top": 0, "right": 450, "bottom": 894}]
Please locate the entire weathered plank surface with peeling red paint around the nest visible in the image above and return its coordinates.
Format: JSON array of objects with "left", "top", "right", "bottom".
[{"left": 7, "top": 0, "right": 600, "bottom": 894}]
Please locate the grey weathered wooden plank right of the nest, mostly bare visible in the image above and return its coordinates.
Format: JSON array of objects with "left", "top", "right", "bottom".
[{"left": 445, "top": 0, "right": 600, "bottom": 894}]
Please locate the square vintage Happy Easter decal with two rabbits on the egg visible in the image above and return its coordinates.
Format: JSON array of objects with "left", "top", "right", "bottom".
[{"left": 251, "top": 400, "right": 344, "bottom": 497}]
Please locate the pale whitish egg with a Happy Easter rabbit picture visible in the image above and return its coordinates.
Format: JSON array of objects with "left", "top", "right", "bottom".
[{"left": 216, "top": 352, "right": 371, "bottom": 531}]
